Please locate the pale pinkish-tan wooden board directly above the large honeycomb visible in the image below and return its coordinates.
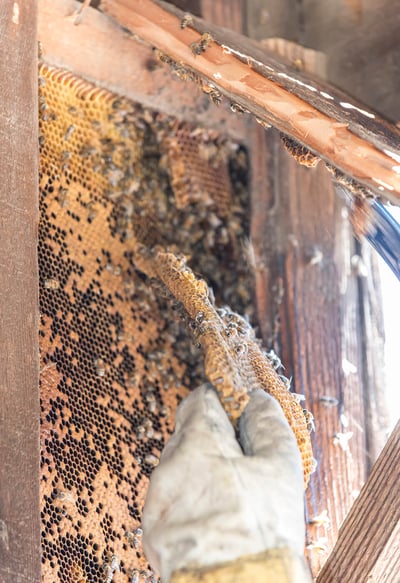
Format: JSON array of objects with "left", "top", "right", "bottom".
[{"left": 38, "top": 0, "right": 246, "bottom": 142}]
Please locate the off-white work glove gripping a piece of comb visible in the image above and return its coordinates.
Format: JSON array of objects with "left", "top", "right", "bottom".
[{"left": 142, "top": 385, "right": 305, "bottom": 583}]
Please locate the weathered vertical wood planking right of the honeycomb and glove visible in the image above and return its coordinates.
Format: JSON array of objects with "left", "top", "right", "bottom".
[{"left": 250, "top": 38, "right": 386, "bottom": 575}]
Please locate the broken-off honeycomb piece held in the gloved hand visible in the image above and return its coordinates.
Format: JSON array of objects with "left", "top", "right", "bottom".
[{"left": 138, "top": 249, "right": 315, "bottom": 487}]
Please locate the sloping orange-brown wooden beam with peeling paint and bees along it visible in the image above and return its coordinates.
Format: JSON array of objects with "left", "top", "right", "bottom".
[{"left": 101, "top": 0, "right": 400, "bottom": 203}]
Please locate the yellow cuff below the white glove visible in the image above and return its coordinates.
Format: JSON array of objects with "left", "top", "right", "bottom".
[{"left": 171, "top": 548, "right": 311, "bottom": 583}]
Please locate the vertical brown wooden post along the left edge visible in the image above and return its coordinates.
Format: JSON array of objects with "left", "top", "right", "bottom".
[{"left": 0, "top": 0, "right": 41, "bottom": 583}]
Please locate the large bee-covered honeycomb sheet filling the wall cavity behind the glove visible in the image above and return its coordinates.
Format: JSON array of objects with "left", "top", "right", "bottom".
[{"left": 39, "top": 64, "right": 254, "bottom": 583}]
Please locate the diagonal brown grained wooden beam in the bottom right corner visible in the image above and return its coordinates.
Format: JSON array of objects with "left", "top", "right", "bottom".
[{"left": 317, "top": 422, "right": 400, "bottom": 583}]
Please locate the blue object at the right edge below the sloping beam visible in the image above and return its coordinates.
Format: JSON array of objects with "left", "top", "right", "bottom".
[{"left": 365, "top": 200, "right": 400, "bottom": 280}]
